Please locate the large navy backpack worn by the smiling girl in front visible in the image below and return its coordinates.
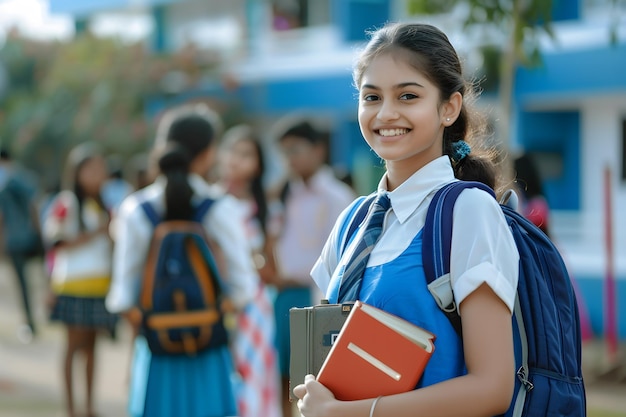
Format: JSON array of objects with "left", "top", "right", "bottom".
[{"left": 344, "top": 181, "right": 586, "bottom": 417}]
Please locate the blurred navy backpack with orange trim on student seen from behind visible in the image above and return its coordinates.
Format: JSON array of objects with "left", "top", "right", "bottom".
[{"left": 138, "top": 200, "right": 228, "bottom": 356}]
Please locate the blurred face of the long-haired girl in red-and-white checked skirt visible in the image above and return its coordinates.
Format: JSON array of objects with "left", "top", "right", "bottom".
[{"left": 220, "top": 140, "right": 259, "bottom": 181}]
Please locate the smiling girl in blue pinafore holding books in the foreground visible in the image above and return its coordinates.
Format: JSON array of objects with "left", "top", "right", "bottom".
[{"left": 294, "top": 24, "right": 519, "bottom": 417}]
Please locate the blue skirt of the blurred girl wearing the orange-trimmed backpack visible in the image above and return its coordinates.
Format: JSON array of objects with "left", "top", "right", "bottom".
[{"left": 128, "top": 336, "right": 237, "bottom": 417}]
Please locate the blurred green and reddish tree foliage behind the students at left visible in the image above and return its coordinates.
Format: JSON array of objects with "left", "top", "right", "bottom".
[{"left": 0, "top": 34, "right": 214, "bottom": 191}]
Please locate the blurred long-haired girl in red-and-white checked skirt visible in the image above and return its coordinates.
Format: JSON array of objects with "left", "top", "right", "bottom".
[{"left": 218, "top": 125, "right": 281, "bottom": 417}]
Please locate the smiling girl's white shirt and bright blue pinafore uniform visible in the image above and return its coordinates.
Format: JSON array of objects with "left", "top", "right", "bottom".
[{"left": 311, "top": 156, "right": 519, "bottom": 387}]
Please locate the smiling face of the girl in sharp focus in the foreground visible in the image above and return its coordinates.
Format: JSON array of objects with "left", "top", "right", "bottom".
[{"left": 359, "top": 52, "right": 453, "bottom": 175}]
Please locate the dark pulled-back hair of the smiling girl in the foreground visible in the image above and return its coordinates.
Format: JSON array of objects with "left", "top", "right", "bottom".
[{"left": 353, "top": 23, "right": 497, "bottom": 188}]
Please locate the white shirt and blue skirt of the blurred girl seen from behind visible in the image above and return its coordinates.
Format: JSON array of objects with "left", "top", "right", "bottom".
[{"left": 106, "top": 175, "right": 258, "bottom": 417}]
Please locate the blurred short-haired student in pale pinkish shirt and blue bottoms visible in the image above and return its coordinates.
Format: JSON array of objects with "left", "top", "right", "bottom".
[{"left": 271, "top": 121, "right": 355, "bottom": 417}]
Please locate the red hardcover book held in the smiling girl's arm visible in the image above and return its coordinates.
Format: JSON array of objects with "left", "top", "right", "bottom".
[{"left": 317, "top": 301, "right": 435, "bottom": 400}]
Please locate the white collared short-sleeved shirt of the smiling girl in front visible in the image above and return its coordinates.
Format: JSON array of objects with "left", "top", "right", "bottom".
[{"left": 311, "top": 156, "right": 519, "bottom": 311}]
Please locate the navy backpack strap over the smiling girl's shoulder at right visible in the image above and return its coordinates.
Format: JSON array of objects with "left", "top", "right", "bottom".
[{"left": 422, "top": 181, "right": 495, "bottom": 335}]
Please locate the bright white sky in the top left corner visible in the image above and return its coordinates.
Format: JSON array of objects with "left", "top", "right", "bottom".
[{"left": 0, "top": 0, "right": 74, "bottom": 44}]
